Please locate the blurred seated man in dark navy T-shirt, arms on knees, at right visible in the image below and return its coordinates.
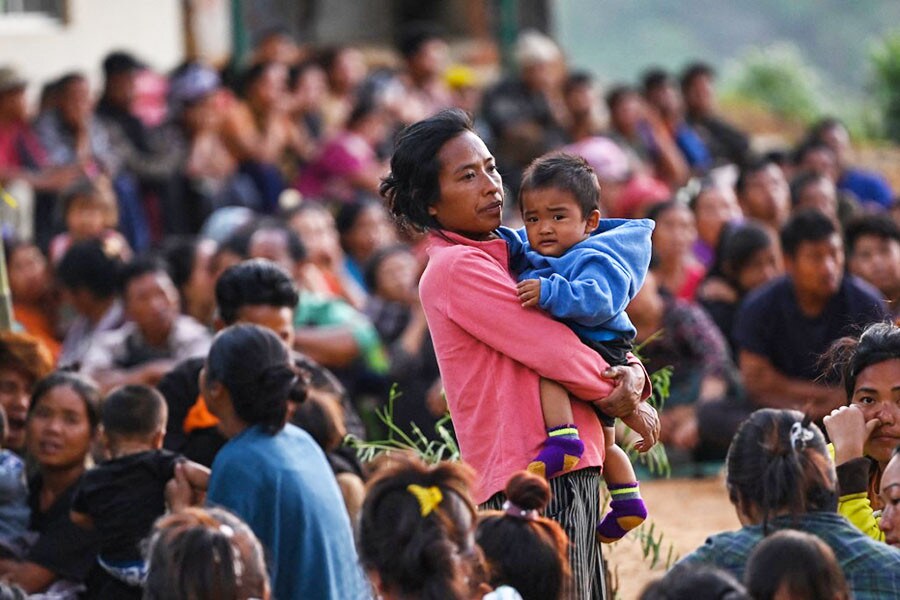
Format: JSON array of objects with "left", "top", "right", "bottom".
[{"left": 734, "top": 210, "right": 888, "bottom": 418}]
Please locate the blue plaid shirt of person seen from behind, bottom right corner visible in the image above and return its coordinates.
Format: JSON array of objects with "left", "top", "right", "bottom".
[{"left": 681, "top": 512, "right": 900, "bottom": 600}]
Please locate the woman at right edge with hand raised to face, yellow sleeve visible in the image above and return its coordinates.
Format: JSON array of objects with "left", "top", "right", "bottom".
[{"left": 823, "top": 323, "right": 900, "bottom": 541}]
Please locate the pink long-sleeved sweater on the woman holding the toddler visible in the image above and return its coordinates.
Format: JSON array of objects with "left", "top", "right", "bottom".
[{"left": 419, "top": 232, "right": 650, "bottom": 503}]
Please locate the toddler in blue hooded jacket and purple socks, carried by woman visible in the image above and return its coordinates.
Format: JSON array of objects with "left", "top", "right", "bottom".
[{"left": 500, "top": 153, "right": 653, "bottom": 542}]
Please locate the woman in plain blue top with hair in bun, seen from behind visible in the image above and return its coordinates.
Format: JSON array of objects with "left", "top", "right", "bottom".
[{"left": 172, "top": 325, "right": 367, "bottom": 600}]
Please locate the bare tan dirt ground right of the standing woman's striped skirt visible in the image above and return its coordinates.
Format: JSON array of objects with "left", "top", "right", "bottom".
[{"left": 604, "top": 477, "right": 740, "bottom": 600}]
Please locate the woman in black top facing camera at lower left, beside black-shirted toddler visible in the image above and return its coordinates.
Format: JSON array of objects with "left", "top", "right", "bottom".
[{"left": 0, "top": 372, "right": 100, "bottom": 594}]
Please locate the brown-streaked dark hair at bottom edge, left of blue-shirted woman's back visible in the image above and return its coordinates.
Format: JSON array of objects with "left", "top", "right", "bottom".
[{"left": 143, "top": 506, "right": 269, "bottom": 600}]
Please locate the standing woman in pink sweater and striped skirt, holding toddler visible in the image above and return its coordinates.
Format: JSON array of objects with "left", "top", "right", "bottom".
[{"left": 381, "top": 110, "right": 659, "bottom": 598}]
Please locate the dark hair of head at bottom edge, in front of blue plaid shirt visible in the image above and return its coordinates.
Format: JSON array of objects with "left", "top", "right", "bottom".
[{"left": 744, "top": 529, "right": 851, "bottom": 600}]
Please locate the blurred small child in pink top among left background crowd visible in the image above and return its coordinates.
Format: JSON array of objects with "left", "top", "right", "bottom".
[{"left": 50, "top": 178, "right": 131, "bottom": 265}]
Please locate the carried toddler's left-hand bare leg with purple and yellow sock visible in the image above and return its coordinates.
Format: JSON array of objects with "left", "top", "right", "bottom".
[{"left": 528, "top": 379, "right": 584, "bottom": 479}]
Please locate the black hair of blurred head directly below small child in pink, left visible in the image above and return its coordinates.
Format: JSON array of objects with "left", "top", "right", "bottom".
[{"left": 56, "top": 240, "right": 125, "bottom": 299}]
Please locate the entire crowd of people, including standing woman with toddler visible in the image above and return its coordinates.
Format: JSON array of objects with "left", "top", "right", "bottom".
[{"left": 0, "top": 24, "right": 900, "bottom": 600}]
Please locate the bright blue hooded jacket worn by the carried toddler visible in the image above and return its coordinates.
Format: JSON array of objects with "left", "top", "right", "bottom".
[{"left": 498, "top": 219, "right": 654, "bottom": 342}]
